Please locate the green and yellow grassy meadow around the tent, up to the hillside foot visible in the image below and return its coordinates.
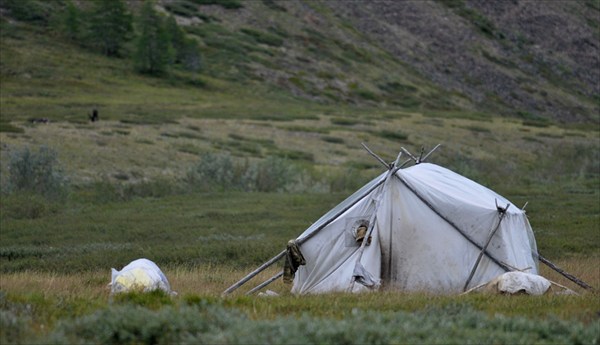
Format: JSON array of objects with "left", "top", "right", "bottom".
[{"left": 0, "top": 10, "right": 600, "bottom": 344}]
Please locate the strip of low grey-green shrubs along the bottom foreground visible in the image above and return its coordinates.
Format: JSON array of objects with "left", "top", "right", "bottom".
[{"left": 47, "top": 299, "right": 600, "bottom": 344}]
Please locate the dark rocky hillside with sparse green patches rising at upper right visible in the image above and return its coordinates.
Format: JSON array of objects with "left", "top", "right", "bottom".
[{"left": 161, "top": 0, "right": 600, "bottom": 122}]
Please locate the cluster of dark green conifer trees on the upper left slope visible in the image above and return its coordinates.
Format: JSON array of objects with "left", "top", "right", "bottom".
[{"left": 59, "top": 0, "right": 200, "bottom": 75}]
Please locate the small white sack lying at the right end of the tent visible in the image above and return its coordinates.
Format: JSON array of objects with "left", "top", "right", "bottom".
[{"left": 487, "top": 271, "right": 551, "bottom": 295}]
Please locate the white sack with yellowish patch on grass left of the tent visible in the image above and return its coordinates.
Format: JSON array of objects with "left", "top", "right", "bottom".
[{"left": 110, "top": 259, "right": 174, "bottom": 294}]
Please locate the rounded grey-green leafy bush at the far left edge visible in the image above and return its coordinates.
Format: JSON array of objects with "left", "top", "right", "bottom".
[{"left": 3, "top": 146, "right": 68, "bottom": 199}]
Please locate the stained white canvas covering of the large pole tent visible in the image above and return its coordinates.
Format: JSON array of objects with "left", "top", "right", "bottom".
[{"left": 292, "top": 163, "right": 537, "bottom": 294}]
